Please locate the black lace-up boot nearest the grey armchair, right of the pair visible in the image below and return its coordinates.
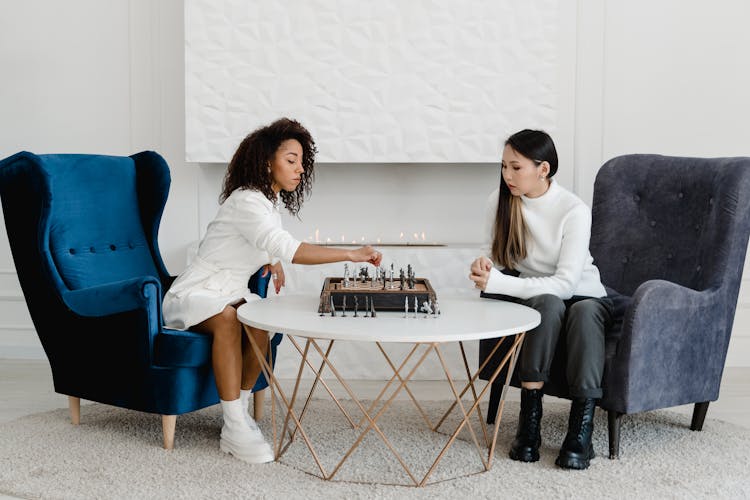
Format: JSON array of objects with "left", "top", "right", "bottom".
[{"left": 555, "top": 398, "right": 596, "bottom": 469}]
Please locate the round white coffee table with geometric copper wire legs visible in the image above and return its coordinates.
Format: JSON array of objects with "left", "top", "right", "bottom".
[{"left": 237, "top": 295, "right": 540, "bottom": 486}]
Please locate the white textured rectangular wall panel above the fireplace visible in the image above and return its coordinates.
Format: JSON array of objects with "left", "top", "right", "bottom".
[{"left": 185, "top": 0, "right": 559, "bottom": 162}]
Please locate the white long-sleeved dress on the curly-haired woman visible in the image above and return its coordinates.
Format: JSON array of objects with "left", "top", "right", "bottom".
[{"left": 162, "top": 189, "right": 300, "bottom": 330}]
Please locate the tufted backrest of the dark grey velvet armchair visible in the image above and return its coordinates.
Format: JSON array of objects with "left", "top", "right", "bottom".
[{"left": 591, "top": 155, "right": 750, "bottom": 300}]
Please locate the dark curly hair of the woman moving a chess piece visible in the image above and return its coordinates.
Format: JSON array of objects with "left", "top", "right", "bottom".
[{"left": 219, "top": 118, "right": 318, "bottom": 215}]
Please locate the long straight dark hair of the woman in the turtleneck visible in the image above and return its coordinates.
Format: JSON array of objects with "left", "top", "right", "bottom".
[{"left": 492, "top": 129, "right": 557, "bottom": 269}]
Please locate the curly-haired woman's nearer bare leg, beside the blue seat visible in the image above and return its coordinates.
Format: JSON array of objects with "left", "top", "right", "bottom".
[{"left": 190, "top": 306, "right": 242, "bottom": 401}]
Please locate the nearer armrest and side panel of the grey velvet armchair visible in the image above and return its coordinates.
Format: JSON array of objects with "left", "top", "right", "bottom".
[{"left": 605, "top": 280, "right": 726, "bottom": 413}]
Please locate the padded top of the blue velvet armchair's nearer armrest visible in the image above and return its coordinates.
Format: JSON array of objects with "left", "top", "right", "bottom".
[{"left": 62, "top": 276, "right": 161, "bottom": 317}]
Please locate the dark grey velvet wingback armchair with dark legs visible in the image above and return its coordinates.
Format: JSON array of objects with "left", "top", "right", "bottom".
[{"left": 480, "top": 155, "right": 750, "bottom": 458}]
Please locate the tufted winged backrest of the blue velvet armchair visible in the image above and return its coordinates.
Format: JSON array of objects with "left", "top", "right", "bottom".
[{"left": 0, "top": 152, "right": 170, "bottom": 299}]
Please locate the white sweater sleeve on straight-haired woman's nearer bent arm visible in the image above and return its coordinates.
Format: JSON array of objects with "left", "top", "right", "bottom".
[{"left": 485, "top": 206, "right": 591, "bottom": 300}]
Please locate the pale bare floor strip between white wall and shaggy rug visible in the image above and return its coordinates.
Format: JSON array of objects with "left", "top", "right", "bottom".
[{"left": 0, "top": 359, "right": 750, "bottom": 500}]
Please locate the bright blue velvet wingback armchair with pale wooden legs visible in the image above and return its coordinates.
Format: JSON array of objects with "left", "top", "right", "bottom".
[{"left": 0, "top": 151, "right": 281, "bottom": 448}]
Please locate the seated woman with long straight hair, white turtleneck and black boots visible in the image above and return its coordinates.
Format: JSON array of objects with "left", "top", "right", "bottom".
[{"left": 469, "top": 130, "right": 612, "bottom": 469}]
